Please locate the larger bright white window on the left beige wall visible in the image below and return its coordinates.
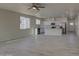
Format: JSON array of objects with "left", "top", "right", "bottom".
[{"left": 20, "top": 16, "right": 30, "bottom": 29}]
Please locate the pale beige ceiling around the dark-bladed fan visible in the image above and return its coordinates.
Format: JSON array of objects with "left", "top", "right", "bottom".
[{"left": 0, "top": 3, "right": 79, "bottom": 18}]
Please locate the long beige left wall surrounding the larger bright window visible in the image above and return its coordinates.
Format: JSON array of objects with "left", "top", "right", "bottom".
[{"left": 0, "top": 9, "right": 41, "bottom": 41}]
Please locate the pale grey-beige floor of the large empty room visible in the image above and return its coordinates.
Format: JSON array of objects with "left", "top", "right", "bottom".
[{"left": 0, "top": 34, "right": 79, "bottom": 56}]
